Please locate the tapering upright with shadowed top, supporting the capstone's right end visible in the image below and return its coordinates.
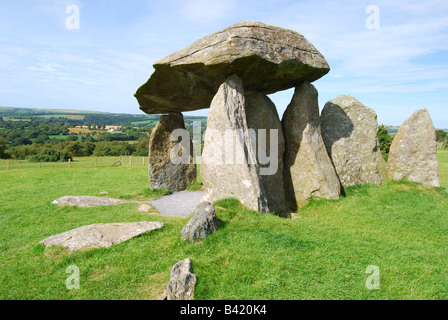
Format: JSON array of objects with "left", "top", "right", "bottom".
[{"left": 282, "top": 81, "right": 341, "bottom": 210}]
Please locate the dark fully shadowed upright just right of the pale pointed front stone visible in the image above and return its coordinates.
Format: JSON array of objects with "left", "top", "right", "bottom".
[{"left": 246, "top": 93, "right": 286, "bottom": 215}]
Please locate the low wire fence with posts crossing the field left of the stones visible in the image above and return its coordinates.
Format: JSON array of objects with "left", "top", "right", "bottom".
[{"left": 0, "top": 156, "right": 148, "bottom": 171}]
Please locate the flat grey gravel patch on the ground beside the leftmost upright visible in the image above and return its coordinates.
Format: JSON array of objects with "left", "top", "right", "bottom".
[{"left": 149, "top": 191, "right": 205, "bottom": 217}]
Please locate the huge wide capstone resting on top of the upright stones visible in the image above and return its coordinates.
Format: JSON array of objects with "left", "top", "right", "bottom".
[{"left": 135, "top": 21, "right": 330, "bottom": 114}]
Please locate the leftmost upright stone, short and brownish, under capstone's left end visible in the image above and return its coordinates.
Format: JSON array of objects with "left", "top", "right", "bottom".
[{"left": 148, "top": 112, "right": 196, "bottom": 192}]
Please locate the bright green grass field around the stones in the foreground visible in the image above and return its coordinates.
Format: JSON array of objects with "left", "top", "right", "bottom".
[{"left": 0, "top": 151, "right": 448, "bottom": 299}]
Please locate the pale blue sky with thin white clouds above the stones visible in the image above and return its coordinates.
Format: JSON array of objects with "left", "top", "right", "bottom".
[{"left": 0, "top": 0, "right": 448, "bottom": 128}]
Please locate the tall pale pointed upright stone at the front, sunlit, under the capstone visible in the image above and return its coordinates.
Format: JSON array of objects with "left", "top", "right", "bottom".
[{"left": 201, "top": 75, "right": 269, "bottom": 212}]
